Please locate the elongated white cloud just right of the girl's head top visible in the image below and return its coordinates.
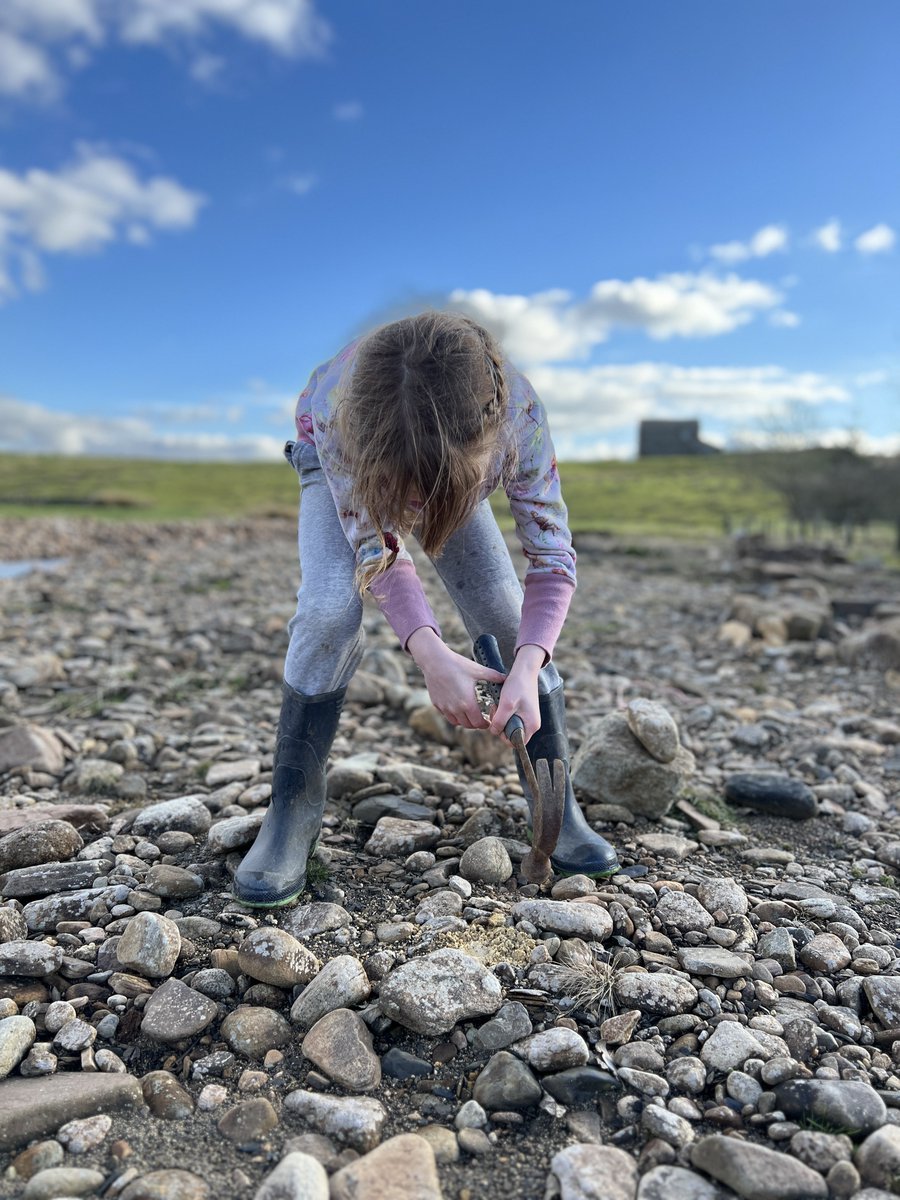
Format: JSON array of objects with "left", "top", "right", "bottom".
[{"left": 449, "top": 272, "right": 782, "bottom": 362}]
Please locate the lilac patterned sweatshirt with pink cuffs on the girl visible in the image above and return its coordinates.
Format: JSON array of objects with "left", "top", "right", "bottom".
[{"left": 295, "top": 338, "right": 575, "bottom": 656}]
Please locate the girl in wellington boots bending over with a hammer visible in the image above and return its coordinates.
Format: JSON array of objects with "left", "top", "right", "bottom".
[{"left": 234, "top": 312, "right": 618, "bottom": 907}]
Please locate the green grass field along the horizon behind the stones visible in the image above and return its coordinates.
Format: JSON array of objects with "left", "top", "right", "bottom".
[{"left": 0, "top": 454, "right": 893, "bottom": 556}]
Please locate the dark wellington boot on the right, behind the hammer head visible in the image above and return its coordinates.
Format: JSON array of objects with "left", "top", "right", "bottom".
[{"left": 518, "top": 683, "right": 619, "bottom": 876}]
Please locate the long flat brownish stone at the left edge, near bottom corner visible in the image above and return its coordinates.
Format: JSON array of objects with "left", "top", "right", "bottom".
[{"left": 0, "top": 1072, "right": 144, "bottom": 1150}]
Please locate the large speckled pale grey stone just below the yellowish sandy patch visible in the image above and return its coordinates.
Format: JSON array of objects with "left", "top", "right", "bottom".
[{"left": 379, "top": 949, "right": 503, "bottom": 1037}]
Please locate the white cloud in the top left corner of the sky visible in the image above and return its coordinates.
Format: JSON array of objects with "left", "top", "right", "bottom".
[{"left": 0, "top": 0, "right": 331, "bottom": 98}]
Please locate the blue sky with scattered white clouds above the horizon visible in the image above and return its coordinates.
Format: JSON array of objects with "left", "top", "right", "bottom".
[{"left": 0, "top": 0, "right": 900, "bottom": 460}]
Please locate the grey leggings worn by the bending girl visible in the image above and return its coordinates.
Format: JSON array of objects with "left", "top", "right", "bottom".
[{"left": 284, "top": 443, "right": 560, "bottom": 696}]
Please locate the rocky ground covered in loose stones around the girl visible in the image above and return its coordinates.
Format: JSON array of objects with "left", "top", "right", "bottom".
[{"left": 0, "top": 521, "right": 900, "bottom": 1200}]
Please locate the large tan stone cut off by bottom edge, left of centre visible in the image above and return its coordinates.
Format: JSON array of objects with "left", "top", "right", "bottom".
[{"left": 331, "top": 1133, "right": 443, "bottom": 1200}]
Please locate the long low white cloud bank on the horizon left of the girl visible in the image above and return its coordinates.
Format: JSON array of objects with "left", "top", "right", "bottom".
[{"left": 0, "top": 395, "right": 284, "bottom": 462}]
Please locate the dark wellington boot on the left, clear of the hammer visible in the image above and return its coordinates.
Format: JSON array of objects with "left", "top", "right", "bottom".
[{"left": 233, "top": 684, "right": 347, "bottom": 908}]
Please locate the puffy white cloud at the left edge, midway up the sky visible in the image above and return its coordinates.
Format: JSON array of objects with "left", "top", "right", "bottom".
[{"left": 0, "top": 145, "right": 205, "bottom": 296}]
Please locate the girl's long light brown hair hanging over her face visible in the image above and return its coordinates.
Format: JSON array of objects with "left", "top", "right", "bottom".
[{"left": 336, "top": 311, "right": 509, "bottom": 592}]
